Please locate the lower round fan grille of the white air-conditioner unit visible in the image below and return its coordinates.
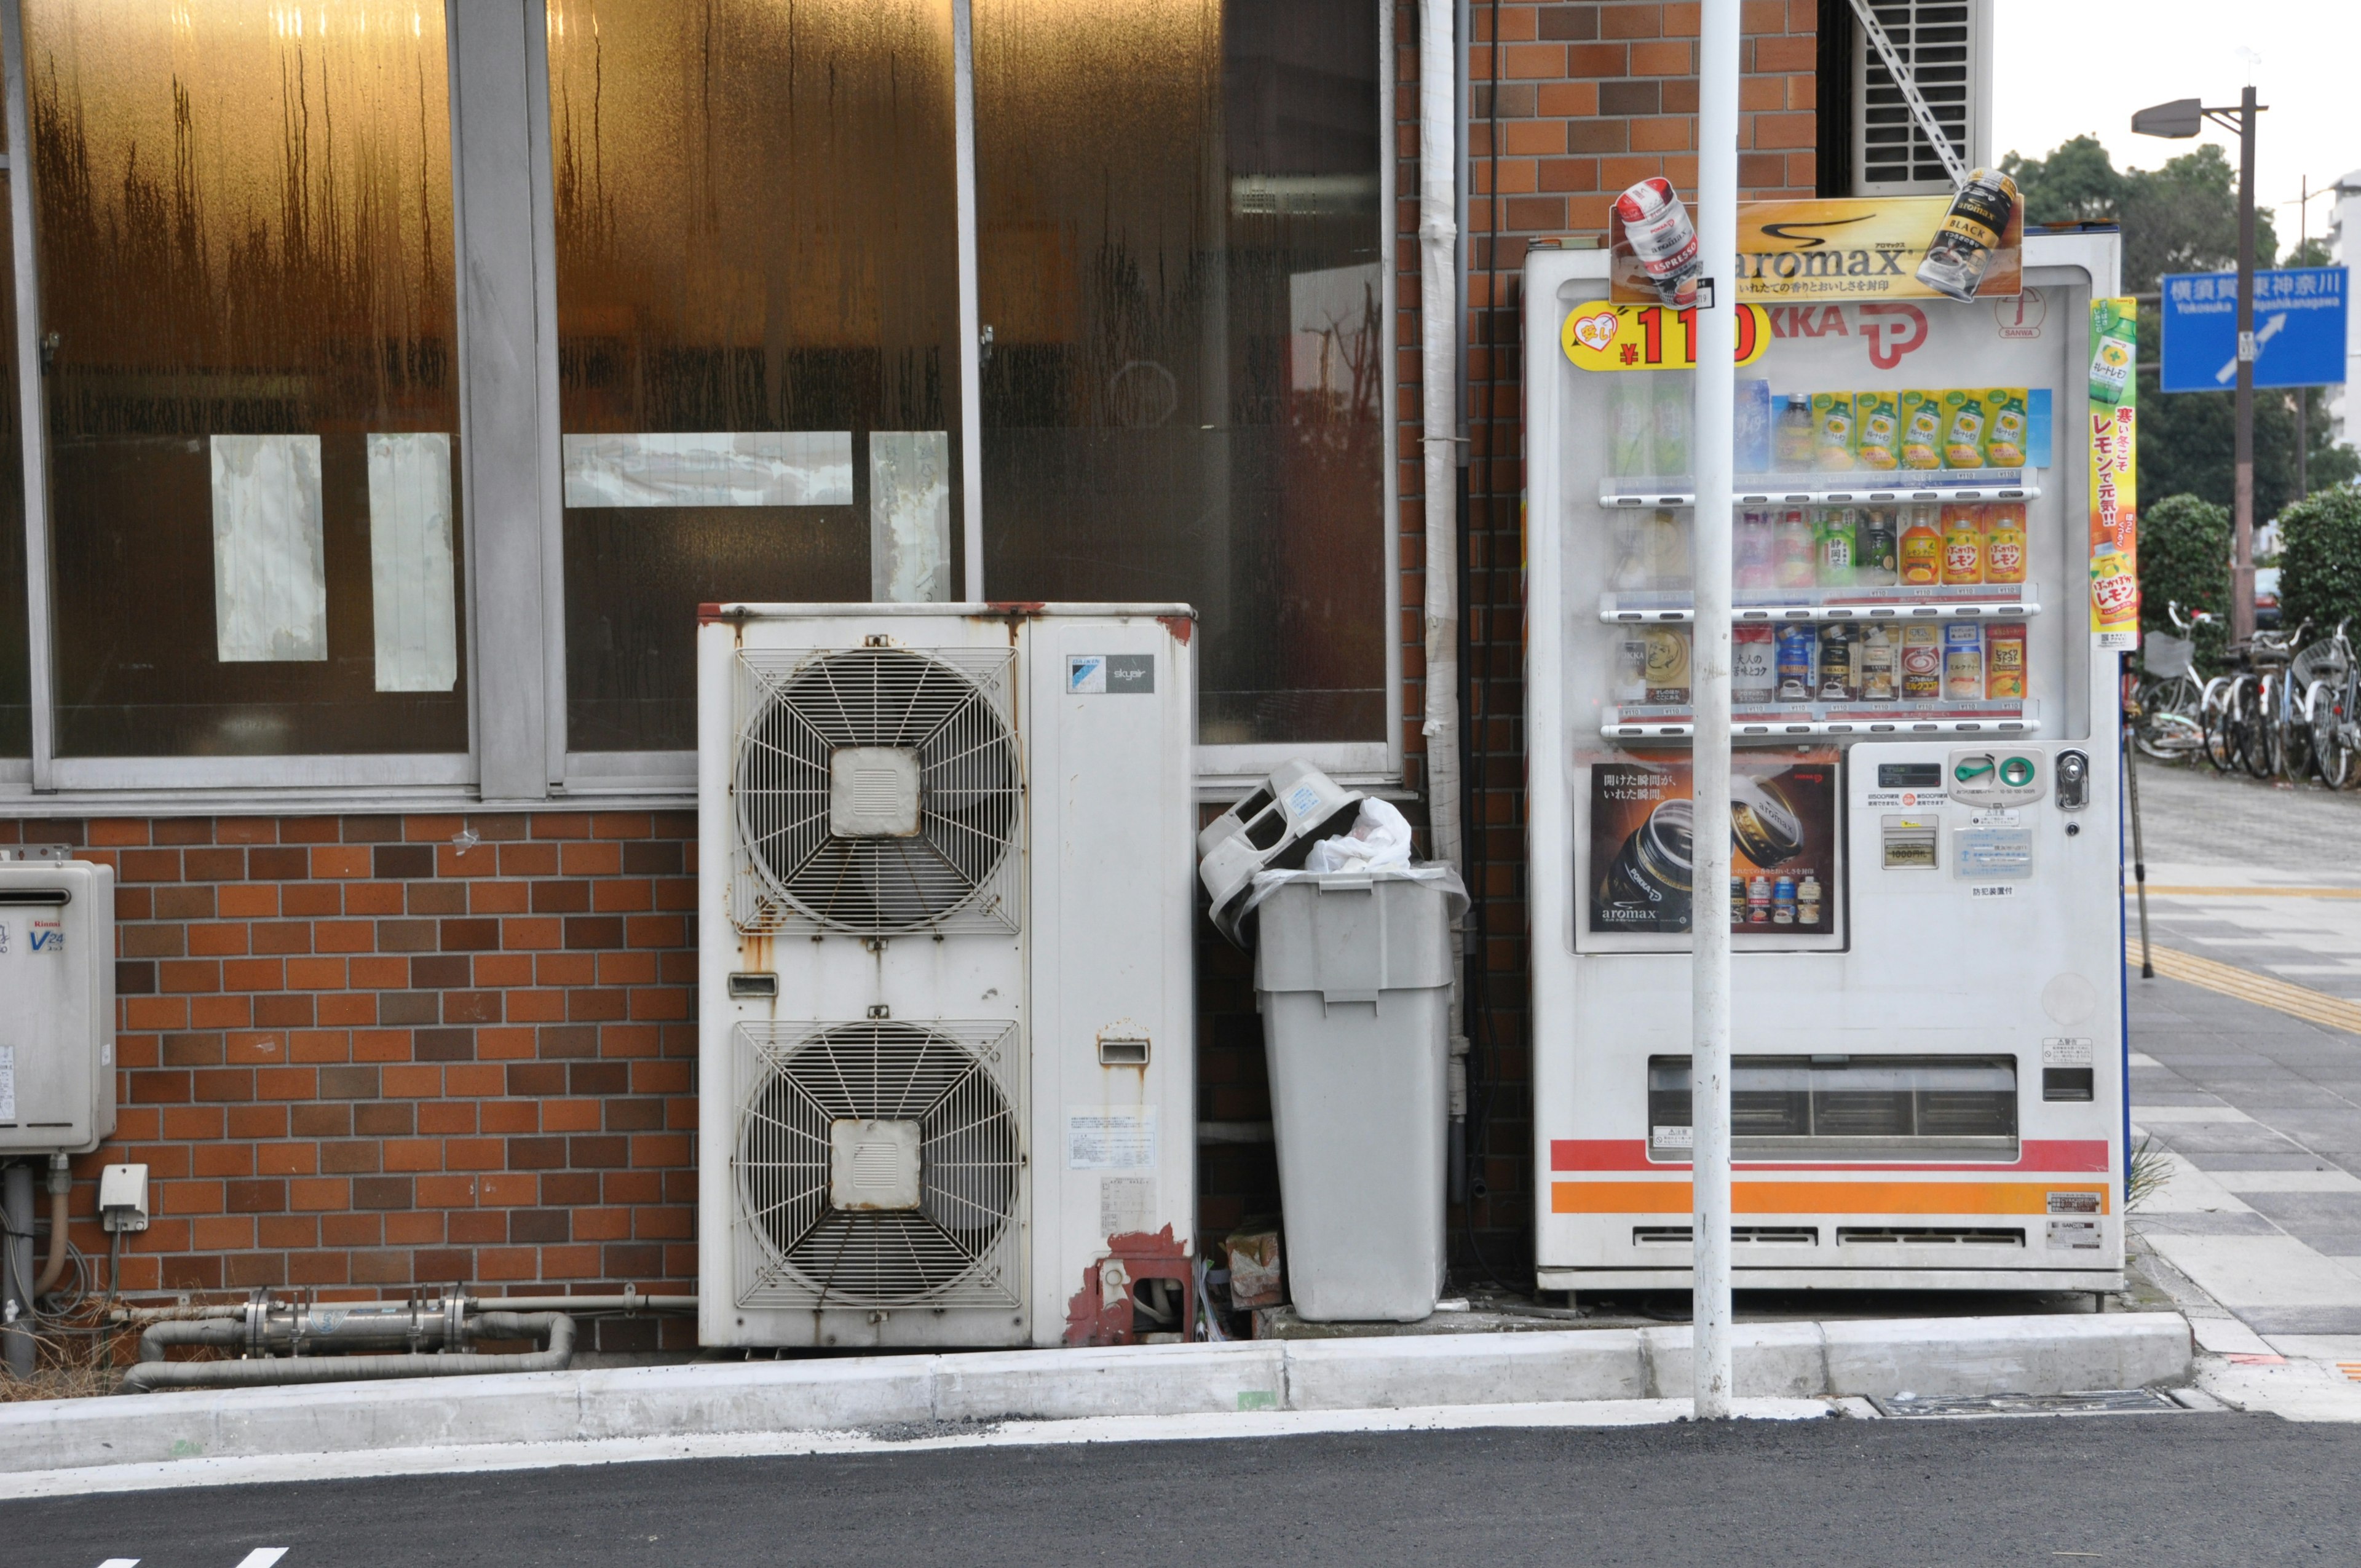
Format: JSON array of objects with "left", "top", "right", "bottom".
[{"left": 734, "top": 1023, "right": 1025, "bottom": 1309}]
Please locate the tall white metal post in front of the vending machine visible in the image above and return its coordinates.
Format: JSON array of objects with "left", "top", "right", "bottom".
[{"left": 1690, "top": 0, "right": 1740, "bottom": 1422}]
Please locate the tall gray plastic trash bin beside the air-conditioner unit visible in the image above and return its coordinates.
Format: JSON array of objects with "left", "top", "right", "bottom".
[{"left": 1254, "top": 866, "right": 1466, "bottom": 1323}]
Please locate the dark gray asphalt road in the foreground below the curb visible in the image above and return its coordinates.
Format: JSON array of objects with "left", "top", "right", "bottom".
[{"left": 0, "top": 1412, "right": 2361, "bottom": 1568}]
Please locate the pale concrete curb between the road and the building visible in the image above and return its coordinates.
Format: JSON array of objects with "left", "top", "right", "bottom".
[{"left": 0, "top": 1313, "right": 2191, "bottom": 1497}]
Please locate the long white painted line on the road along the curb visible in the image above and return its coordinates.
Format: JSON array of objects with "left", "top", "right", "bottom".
[{"left": 0, "top": 1398, "right": 1861, "bottom": 1502}]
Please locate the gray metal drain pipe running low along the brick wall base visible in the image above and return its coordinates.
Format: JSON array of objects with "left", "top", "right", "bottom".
[{"left": 116, "top": 1299, "right": 574, "bottom": 1393}]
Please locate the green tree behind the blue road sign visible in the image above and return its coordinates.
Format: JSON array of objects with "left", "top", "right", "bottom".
[{"left": 1999, "top": 137, "right": 2361, "bottom": 515}]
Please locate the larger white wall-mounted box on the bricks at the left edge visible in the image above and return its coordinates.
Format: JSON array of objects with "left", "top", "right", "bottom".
[{"left": 0, "top": 860, "right": 116, "bottom": 1155}]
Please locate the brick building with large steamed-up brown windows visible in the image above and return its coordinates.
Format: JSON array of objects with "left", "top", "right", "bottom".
[{"left": 0, "top": 0, "right": 1990, "bottom": 1348}]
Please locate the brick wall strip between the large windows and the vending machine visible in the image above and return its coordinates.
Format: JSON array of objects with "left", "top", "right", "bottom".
[{"left": 1395, "top": 0, "right": 1818, "bottom": 1282}]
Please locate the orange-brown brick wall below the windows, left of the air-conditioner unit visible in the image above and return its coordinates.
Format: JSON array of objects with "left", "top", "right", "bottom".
[{"left": 0, "top": 812, "right": 697, "bottom": 1348}]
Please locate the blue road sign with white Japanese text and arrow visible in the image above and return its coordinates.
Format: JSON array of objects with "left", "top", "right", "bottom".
[{"left": 2162, "top": 267, "right": 2344, "bottom": 392}]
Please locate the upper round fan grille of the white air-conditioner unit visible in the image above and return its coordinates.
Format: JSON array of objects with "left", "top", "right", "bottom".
[{"left": 732, "top": 647, "right": 1022, "bottom": 935}]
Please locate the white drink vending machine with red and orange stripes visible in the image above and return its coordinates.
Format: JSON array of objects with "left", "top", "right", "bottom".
[{"left": 1525, "top": 223, "right": 2137, "bottom": 1292}]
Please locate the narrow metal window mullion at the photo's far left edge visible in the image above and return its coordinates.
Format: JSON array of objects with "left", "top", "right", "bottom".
[{"left": 0, "top": 0, "right": 57, "bottom": 791}]
